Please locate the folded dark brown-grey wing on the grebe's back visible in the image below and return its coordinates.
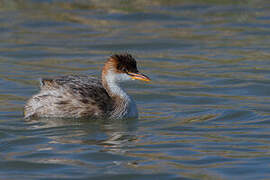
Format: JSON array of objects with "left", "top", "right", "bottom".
[{"left": 41, "top": 75, "right": 113, "bottom": 115}]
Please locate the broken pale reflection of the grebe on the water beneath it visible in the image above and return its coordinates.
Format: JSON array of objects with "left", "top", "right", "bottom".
[{"left": 24, "top": 118, "right": 138, "bottom": 153}]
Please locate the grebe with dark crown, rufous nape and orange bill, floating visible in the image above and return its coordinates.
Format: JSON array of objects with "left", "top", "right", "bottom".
[{"left": 24, "top": 54, "right": 150, "bottom": 118}]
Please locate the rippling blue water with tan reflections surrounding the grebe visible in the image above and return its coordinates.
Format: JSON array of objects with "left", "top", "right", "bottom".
[{"left": 0, "top": 0, "right": 270, "bottom": 180}]
